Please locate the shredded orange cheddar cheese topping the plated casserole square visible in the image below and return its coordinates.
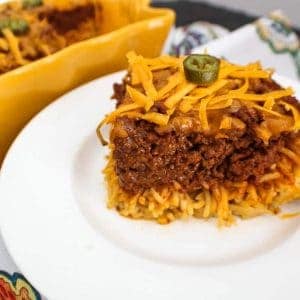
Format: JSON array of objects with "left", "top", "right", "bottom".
[{"left": 103, "top": 52, "right": 300, "bottom": 142}]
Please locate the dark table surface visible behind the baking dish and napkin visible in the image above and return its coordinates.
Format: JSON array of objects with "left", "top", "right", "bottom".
[{"left": 153, "top": 0, "right": 300, "bottom": 34}]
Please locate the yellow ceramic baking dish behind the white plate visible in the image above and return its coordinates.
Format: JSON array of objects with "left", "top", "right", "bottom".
[{"left": 0, "top": 0, "right": 174, "bottom": 163}]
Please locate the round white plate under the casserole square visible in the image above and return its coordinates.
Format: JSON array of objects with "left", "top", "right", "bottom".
[{"left": 0, "top": 73, "right": 300, "bottom": 300}]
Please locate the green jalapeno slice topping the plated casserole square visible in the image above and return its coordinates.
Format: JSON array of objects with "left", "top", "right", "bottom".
[{"left": 183, "top": 54, "right": 220, "bottom": 85}]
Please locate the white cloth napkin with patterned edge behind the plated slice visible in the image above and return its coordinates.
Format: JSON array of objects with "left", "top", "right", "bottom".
[{"left": 192, "top": 12, "right": 300, "bottom": 80}]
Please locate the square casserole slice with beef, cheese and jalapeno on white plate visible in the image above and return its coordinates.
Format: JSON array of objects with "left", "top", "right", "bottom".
[{"left": 97, "top": 53, "right": 300, "bottom": 225}]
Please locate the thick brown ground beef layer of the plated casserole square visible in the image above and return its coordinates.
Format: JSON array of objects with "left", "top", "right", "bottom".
[{"left": 112, "top": 108, "right": 290, "bottom": 193}]
